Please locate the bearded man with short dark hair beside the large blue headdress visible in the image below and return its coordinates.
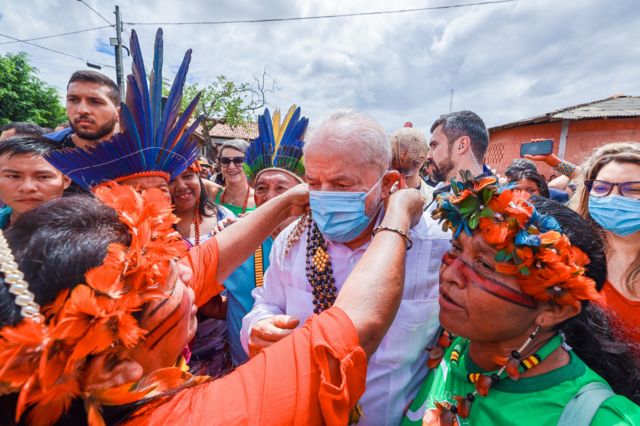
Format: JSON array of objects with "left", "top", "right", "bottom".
[{"left": 46, "top": 71, "right": 120, "bottom": 148}]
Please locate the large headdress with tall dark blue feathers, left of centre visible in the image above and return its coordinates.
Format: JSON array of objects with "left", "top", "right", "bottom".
[{"left": 47, "top": 28, "right": 200, "bottom": 190}]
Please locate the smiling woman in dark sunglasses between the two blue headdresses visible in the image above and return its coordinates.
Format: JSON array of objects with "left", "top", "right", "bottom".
[{"left": 216, "top": 139, "right": 256, "bottom": 216}]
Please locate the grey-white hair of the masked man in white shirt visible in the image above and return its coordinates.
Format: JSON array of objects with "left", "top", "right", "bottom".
[{"left": 304, "top": 110, "right": 391, "bottom": 174}]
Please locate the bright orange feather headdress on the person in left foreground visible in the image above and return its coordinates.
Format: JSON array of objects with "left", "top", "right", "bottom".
[{"left": 0, "top": 184, "right": 206, "bottom": 425}]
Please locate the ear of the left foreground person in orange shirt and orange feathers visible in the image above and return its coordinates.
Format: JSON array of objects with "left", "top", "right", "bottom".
[{"left": 82, "top": 355, "right": 143, "bottom": 392}]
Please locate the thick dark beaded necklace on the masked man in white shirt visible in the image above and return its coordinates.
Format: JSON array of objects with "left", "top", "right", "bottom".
[{"left": 306, "top": 221, "right": 338, "bottom": 314}]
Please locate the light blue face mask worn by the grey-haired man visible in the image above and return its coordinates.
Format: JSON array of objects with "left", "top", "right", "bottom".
[{"left": 309, "top": 176, "right": 384, "bottom": 243}]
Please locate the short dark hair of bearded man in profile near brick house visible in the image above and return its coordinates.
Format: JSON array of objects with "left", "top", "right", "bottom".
[{"left": 431, "top": 111, "right": 489, "bottom": 163}]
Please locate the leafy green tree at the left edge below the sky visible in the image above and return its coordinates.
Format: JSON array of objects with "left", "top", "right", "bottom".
[{"left": 0, "top": 52, "right": 67, "bottom": 128}]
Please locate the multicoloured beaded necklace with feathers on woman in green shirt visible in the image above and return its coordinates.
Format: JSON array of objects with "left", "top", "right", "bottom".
[{"left": 434, "top": 329, "right": 564, "bottom": 425}]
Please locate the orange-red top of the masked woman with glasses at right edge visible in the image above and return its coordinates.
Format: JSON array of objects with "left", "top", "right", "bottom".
[{"left": 596, "top": 281, "right": 640, "bottom": 344}]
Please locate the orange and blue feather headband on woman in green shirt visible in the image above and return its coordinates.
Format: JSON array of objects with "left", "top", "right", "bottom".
[{"left": 433, "top": 170, "right": 598, "bottom": 306}]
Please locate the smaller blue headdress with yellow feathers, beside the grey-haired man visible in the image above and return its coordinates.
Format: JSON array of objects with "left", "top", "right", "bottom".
[{"left": 242, "top": 105, "right": 309, "bottom": 182}]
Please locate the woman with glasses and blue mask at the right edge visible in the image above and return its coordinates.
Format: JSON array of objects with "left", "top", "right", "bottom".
[{"left": 575, "top": 142, "right": 640, "bottom": 342}]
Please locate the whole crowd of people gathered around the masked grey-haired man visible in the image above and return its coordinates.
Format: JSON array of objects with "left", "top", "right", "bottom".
[{"left": 0, "top": 30, "right": 640, "bottom": 425}]
